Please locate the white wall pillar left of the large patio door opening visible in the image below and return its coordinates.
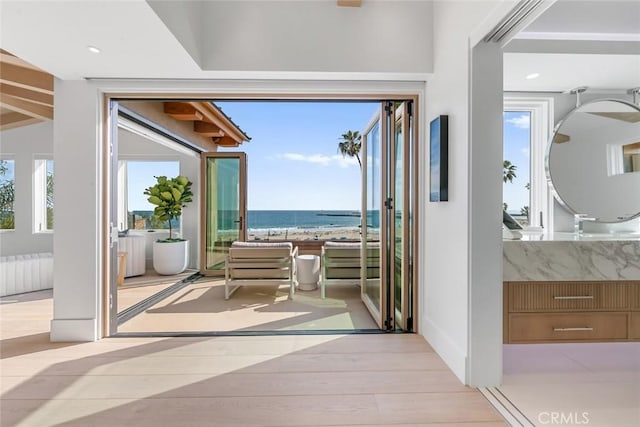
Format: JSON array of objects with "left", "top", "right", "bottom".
[{"left": 51, "top": 79, "right": 106, "bottom": 341}]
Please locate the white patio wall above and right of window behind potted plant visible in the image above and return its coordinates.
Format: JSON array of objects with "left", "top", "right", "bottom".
[{"left": 118, "top": 129, "right": 200, "bottom": 268}]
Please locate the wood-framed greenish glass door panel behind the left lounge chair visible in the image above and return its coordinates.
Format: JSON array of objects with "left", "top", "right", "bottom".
[{"left": 201, "top": 153, "right": 247, "bottom": 275}]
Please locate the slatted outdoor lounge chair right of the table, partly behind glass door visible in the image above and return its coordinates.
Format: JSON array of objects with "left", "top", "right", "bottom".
[{"left": 320, "top": 242, "right": 380, "bottom": 298}]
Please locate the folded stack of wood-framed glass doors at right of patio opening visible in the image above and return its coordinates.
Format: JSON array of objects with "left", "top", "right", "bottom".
[{"left": 361, "top": 101, "right": 416, "bottom": 330}]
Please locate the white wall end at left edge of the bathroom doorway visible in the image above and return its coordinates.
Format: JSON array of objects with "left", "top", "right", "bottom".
[{"left": 465, "top": 43, "right": 503, "bottom": 386}]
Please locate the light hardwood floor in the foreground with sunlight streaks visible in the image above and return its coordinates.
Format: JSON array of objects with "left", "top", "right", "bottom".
[{"left": 0, "top": 291, "right": 506, "bottom": 427}]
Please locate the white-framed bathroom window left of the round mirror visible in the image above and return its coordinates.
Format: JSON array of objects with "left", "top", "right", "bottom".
[{"left": 503, "top": 97, "right": 553, "bottom": 230}]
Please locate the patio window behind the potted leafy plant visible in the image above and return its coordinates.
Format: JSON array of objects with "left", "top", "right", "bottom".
[{"left": 118, "top": 160, "right": 180, "bottom": 230}]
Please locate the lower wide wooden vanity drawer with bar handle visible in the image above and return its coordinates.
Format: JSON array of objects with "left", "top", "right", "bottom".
[{"left": 509, "top": 312, "right": 628, "bottom": 343}]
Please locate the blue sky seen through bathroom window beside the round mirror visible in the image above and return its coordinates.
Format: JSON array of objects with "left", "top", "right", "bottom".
[{"left": 503, "top": 111, "right": 531, "bottom": 213}]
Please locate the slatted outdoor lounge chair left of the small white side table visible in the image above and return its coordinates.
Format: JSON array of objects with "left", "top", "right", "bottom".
[{"left": 224, "top": 242, "right": 298, "bottom": 299}]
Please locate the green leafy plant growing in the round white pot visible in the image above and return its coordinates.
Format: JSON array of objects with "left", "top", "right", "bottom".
[{"left": 144, "top": 175, "right": 193, "bottom": 242}]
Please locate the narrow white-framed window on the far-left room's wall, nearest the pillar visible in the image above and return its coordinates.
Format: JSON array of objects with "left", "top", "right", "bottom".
[{"left": 33, "top": 159, "right": 53, "bottom": 233}]
